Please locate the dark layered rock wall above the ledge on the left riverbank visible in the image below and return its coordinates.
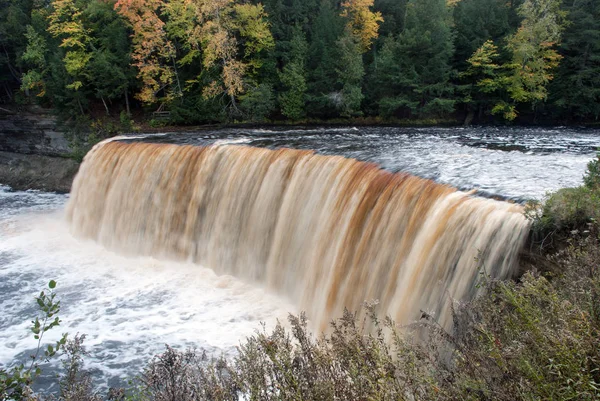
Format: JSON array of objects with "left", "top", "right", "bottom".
[{"left": 0, "top": 113, "right": 69, "bottom": 156}]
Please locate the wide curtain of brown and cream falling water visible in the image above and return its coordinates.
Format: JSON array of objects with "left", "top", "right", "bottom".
[{"left": 67, "top": 141, "right": 529, "bottom": 329}]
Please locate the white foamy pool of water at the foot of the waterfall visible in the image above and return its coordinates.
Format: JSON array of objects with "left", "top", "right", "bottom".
[{"left": 0, "top": 205, "right": 293, "bottom": 386}]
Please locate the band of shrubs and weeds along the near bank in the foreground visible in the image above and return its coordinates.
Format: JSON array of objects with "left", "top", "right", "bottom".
[{"left": 0, "top": 158, "right": 600, "bottom": 401}]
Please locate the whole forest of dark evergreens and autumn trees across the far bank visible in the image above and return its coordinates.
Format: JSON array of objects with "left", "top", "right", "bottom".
[{"left": 0, "top": 0, "right": 600, "bottom": 124}]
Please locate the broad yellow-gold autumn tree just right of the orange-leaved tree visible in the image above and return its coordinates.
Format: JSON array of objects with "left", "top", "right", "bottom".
[{"left": 159, "top": 0, "right": 274, "bottom": 114}]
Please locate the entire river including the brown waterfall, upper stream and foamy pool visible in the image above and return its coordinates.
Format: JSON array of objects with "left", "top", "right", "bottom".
[{"left": 0, "top": 127, "right": 600, "bottom": 391}]
